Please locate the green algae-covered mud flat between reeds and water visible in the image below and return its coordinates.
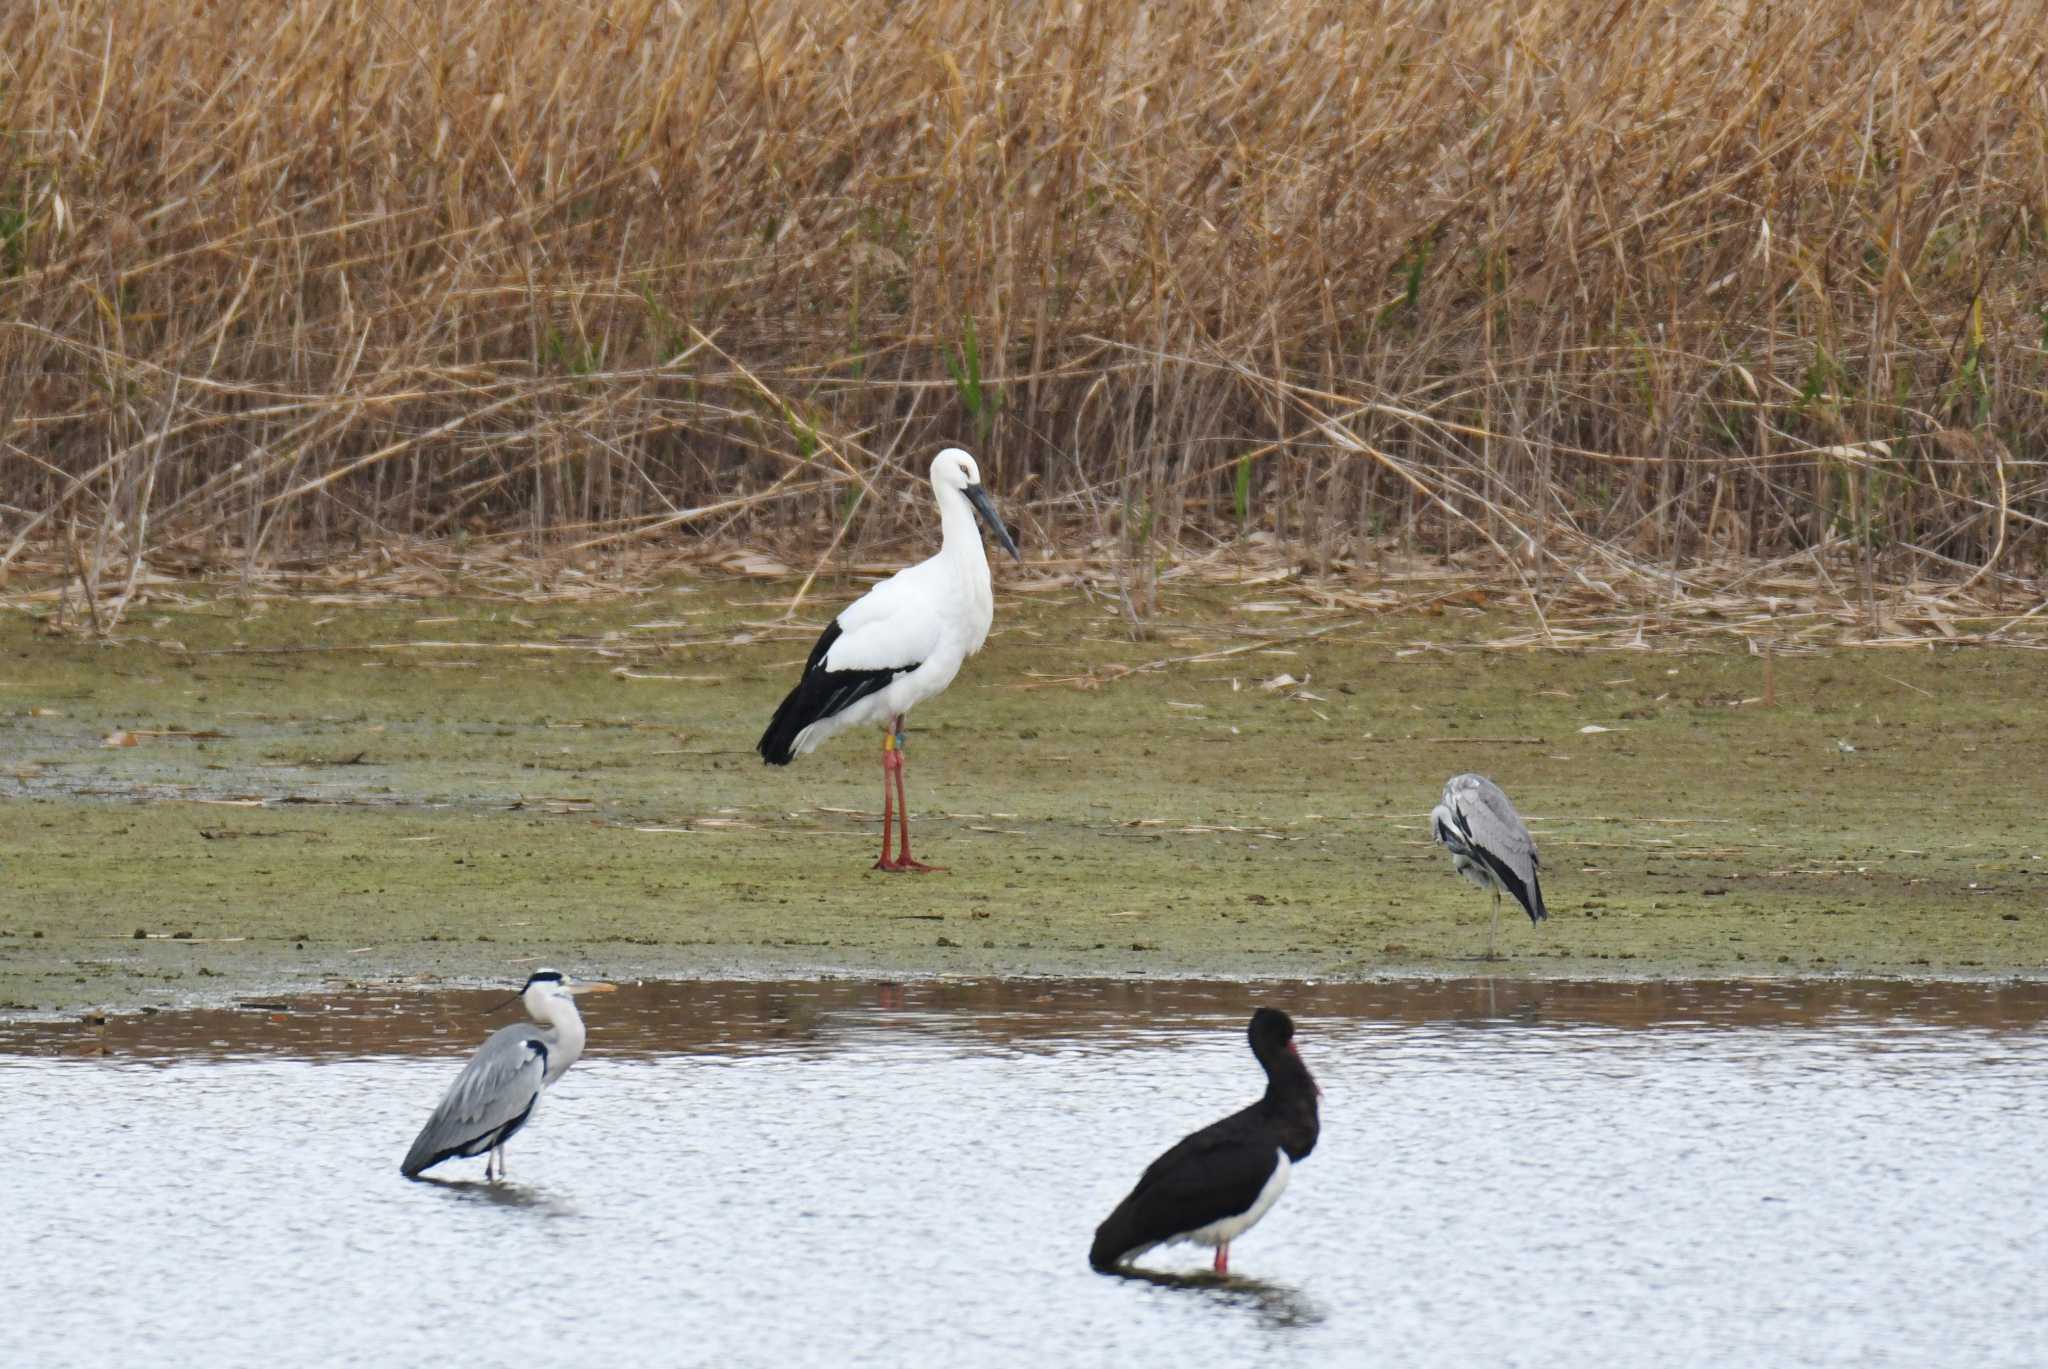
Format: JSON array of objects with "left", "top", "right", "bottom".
[{"left": 0, "top": 580, "right": 2048, "bottom": 1010}]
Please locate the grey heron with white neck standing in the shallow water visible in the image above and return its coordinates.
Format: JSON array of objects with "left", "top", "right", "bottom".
[{"left": 399, "top": 969, "right": 612, "bottom": 1180}]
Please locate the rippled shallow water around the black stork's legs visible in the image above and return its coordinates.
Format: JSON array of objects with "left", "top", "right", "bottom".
[{"left": 12, "top": 982, "right": 2048, "bottom": 1367}]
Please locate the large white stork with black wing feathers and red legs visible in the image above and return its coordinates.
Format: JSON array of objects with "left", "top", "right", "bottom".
[{"left": 758, "top": 447, "right": 1024, "bottom": 871}]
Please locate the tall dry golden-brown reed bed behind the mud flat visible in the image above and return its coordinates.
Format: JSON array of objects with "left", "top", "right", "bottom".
[{"left": 0, "top": 0, "right": 2048, "bottom": 623}]
